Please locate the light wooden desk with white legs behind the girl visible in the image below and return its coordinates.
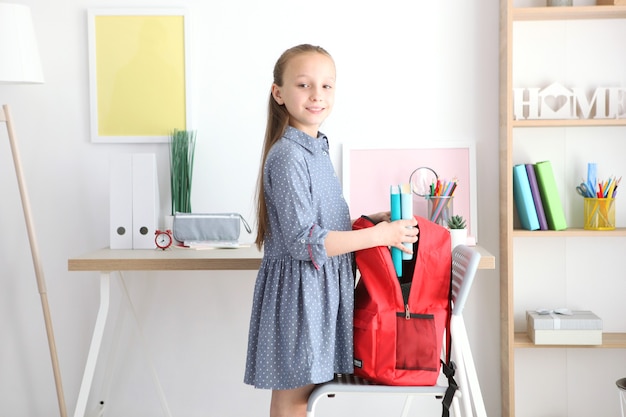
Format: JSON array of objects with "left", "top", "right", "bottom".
[{"left": 67, "top": 246, "right": 495, "bottom": 417}]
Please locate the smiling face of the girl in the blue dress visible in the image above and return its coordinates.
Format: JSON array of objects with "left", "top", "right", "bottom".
[{"left": 272, "top": 52, "right": 335, "bottom": 138}]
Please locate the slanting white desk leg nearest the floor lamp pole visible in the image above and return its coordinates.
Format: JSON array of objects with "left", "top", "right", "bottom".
[{"left": 74, "top": 272, "right": 111, "bottom": 417}]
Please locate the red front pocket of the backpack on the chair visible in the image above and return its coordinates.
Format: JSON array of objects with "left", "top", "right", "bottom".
[{"left": 396, "top": 312, "right": 441, "bottom": 372}]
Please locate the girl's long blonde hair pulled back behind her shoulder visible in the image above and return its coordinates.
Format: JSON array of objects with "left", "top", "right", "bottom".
[{"left": 254, "top": 44, "right": 332, "bottom": 250}]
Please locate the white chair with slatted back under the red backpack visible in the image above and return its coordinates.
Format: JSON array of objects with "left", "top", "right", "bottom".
[{"left": 307, "top": 245, "right": 487, "bottom": 417}]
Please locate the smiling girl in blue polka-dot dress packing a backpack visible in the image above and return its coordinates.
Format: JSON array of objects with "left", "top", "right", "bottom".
[{"left": 244, "top": 45, "right": 418, "bottom": 417}]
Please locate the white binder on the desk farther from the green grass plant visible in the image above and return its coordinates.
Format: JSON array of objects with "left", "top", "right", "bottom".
[{"left": 109, "top": 154, "right": 133, "bottom": 249}]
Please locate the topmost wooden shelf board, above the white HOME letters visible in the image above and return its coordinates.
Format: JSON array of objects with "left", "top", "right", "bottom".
[{"left": 513, "top": 6, "right": 626, "bottom": 22}]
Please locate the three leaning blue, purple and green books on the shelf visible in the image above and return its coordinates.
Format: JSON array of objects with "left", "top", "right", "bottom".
[{"left": 513, "top": 161, "right": 567, "bottom": 230}]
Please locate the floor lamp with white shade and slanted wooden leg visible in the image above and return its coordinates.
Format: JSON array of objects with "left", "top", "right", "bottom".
[{"left": 0, "top": 3, "right": 67, "bottom": 417}]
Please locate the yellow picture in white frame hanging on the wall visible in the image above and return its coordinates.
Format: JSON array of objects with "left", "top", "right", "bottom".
[{"left": 88, "top": 8, "right": 190, "bottom": 143}]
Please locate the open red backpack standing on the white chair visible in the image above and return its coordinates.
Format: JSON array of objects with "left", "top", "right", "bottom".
[{"left": 353, "top": 216, "right": 456, "bottom": 399}]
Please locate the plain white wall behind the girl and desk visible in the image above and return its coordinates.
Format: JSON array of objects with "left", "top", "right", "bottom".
[{"left": 0, "top": 0, "right": 500, "bottom": 417}]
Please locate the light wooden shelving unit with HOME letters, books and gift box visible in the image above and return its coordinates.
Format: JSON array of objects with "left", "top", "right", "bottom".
[{"left": 500, "top": 0, "right": 626, "bottom": 417}]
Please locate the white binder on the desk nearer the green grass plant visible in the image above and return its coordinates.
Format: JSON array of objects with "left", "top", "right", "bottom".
[{"left": 132, "top": 153, "right": 159, "bottom": 249}]
